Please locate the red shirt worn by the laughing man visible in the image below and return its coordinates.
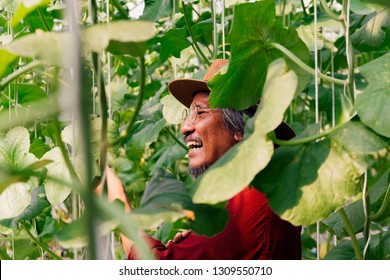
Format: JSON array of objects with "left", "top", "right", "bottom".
[{"left": 128, "top": 188, "right": 301, "bottom": 260}]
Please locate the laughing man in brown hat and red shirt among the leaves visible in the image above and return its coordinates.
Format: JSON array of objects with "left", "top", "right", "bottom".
[{"left": 101, "top": 60, "right": 301, "bottom": 260}]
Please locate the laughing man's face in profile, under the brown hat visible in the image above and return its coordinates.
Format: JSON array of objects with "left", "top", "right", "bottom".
[{"left": 181, "top": 92, "right": 237, "bottom": 175}]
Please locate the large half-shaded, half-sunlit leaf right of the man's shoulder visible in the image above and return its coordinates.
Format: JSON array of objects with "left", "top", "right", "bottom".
[{"left": 255, "top": 122, "right": 380, "bottom": 225}]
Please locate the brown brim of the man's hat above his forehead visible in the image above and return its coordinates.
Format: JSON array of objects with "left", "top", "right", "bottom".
[{"left": 168, "top": 79, "right": 210, "bottom": 108}]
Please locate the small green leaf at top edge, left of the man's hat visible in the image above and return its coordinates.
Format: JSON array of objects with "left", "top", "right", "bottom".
[{"left": 140, "top": 0, "right": 174, "bottom": 21}]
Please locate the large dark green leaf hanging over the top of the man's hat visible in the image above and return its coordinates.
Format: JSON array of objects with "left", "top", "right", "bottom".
[{"left": 209, "top": 0, "right": 309, "bottom": 109}]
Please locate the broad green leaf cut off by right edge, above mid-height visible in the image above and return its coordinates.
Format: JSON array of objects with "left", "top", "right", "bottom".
[{"left": 356, "top": 53, "right": 390, "bottom": 138}]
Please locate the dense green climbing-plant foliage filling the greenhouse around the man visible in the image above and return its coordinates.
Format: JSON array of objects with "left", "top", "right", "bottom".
[{"left": 0, "top": 0, "right": 390, "bottom": 259}]
